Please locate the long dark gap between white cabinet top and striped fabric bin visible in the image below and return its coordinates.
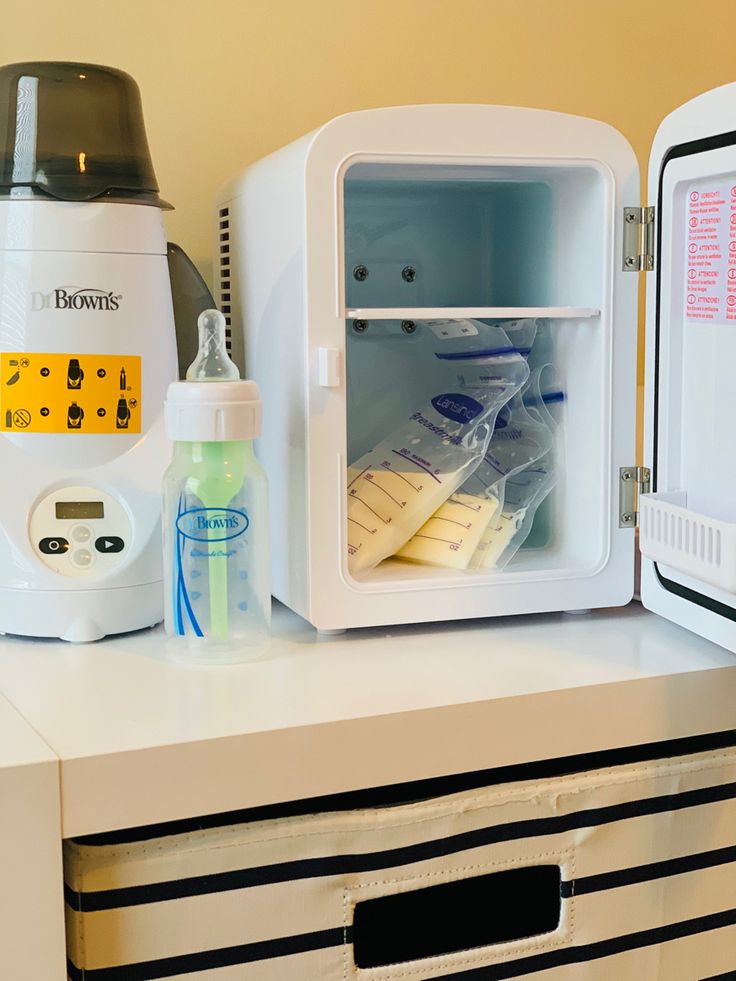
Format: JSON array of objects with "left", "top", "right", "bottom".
[{"left": 71, "top": 732, "right": 736, "bottom": 847}]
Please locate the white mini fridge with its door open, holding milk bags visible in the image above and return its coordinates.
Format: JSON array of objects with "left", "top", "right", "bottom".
[{"left": 216, "top": 85, "right": 736, "bottom": 650}]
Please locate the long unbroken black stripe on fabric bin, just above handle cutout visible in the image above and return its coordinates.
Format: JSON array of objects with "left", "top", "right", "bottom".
[{"left": 65, "top": 783, "right": 736, "bottom": 913}]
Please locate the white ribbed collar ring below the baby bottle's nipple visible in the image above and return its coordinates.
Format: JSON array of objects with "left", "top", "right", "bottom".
[{"left": 164, "top": 381, "right": 263, "bottom": 443}]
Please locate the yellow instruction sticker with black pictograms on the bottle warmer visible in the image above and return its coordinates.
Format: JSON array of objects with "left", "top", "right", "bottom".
[{"left": 0, "top": 351, "right": 141, "bottom": 433}]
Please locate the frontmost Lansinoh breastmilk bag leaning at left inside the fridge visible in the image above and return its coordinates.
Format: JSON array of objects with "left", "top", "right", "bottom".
[{"left": 347, "top": 321, "right": 529, "bottom": 573}]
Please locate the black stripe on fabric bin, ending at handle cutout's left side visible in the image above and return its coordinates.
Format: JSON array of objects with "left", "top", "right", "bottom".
[{"left": 67, "top": 927, "right": 352, "bottom": 981}]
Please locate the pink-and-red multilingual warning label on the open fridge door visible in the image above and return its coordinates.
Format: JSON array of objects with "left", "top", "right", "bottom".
[{"left": 685, "top": 178, "right": 736, "bottom": 323}]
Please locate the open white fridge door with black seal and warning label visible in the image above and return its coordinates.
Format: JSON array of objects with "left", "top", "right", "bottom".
[{"left": 639, "top": 84, "right": 736, "bottom": 651}]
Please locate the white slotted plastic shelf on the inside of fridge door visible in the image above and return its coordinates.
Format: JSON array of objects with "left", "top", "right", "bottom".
[{"left": 639, "top": 491, "right": 736, "bottom": 593}]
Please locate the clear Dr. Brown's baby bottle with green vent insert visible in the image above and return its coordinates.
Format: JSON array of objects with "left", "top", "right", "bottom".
[{"left": 163, "top": 310, "right": 271, "bottom": 663}]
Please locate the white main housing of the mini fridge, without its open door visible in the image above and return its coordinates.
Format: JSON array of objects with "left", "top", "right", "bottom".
[{"left": 217, "top": 106, "right": 639, "bottom": 629}]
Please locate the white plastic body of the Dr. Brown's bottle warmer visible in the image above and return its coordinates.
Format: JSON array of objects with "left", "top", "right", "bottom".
[{"left": 0, "top": 199, "right": 177, "bottom": 640}]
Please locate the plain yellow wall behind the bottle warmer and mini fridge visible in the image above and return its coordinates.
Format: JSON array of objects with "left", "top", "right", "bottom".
[{"left": 0, "top": 0, "right": 736, "bottom": 376}]
